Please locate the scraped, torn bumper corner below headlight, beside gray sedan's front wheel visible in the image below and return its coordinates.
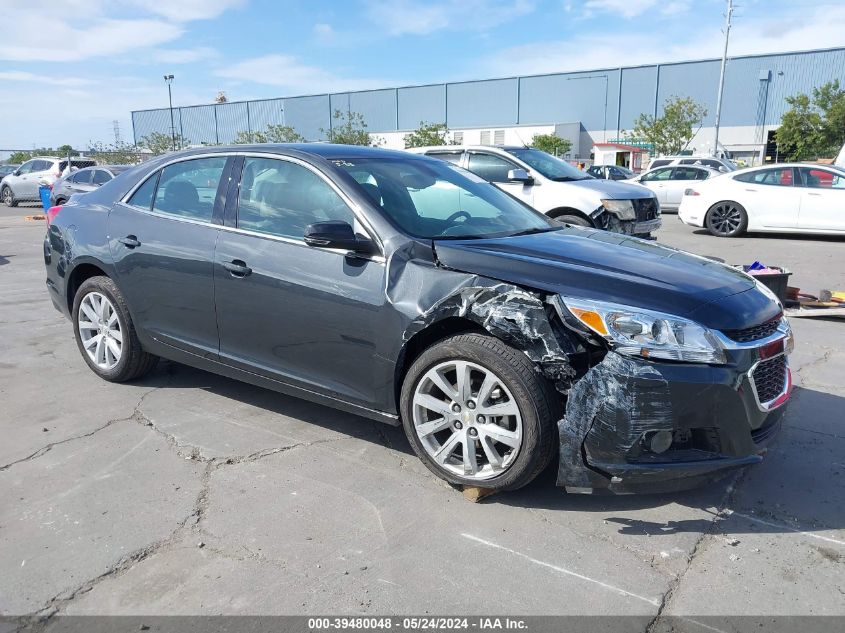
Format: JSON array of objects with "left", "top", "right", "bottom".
[{"left": 557, "top": 352, "right": 673, "bottom": 488}]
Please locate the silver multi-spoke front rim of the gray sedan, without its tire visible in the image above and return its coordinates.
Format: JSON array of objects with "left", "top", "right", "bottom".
[{"left": 413, "top": 360, "right": 523, "bottom": 481}]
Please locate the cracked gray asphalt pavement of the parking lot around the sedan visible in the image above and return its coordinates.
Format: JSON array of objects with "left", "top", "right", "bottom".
[{"left": 0, "top": 207, "right": 845, "bottom": 631}]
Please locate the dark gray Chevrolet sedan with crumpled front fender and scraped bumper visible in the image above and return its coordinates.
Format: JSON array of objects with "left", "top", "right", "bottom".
[{"left": 39, "top": 144, "right": 793, "bottom": 492}]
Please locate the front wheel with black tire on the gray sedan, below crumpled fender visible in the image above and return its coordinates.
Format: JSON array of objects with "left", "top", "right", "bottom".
[{"left": 400, "top": 334, "right": 561, "bottom": 490}]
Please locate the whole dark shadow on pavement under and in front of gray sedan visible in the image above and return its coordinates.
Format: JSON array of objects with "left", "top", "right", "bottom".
[{"left": 134, "top": 362, "right": 845, "bottom": 536}]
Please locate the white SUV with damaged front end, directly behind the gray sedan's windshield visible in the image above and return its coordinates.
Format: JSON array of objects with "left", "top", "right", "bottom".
[{"left": 407, "top": 145, "right": 662, "bottom": 237}]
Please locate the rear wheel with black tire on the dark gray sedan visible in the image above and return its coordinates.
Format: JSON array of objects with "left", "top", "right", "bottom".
[{"left": 71, "top": 276, "right": 158, "bottom": 382}]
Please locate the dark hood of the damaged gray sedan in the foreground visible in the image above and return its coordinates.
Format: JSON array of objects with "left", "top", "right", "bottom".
[{"left": 435, "top": 227, "right": 780, "bottom": 330}]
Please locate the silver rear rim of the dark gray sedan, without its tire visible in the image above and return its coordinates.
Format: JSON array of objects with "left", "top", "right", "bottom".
[{"left": 77, "top": 292, "right": 123, "bottom": 370}]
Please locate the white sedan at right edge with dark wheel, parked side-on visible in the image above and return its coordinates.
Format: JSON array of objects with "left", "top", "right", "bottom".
[{"left": 678, "top": 164, "right": 845, "bottom": 237}]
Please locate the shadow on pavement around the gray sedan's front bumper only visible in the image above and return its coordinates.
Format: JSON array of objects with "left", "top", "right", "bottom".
[{"left": 494, "top": 388, "right": 845, "bottom": 545}]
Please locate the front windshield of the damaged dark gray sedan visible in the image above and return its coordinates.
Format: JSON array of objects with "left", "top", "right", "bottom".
[{"left": 331, "top": 158, "right": 559, "bottom": 239}]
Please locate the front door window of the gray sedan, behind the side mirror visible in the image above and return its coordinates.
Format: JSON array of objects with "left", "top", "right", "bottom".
[{"left": 238, "top": 158, "right": 354, "bottom": 240}]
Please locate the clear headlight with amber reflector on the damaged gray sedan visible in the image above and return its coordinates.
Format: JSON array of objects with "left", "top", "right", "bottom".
[{"left": 561, "top": 296, "right": 727, "bottom": 365}]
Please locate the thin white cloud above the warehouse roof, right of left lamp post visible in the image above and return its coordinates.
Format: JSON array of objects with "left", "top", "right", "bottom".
[{"left": 215, "top": 55, "right": 386, "bottom": 95}]
